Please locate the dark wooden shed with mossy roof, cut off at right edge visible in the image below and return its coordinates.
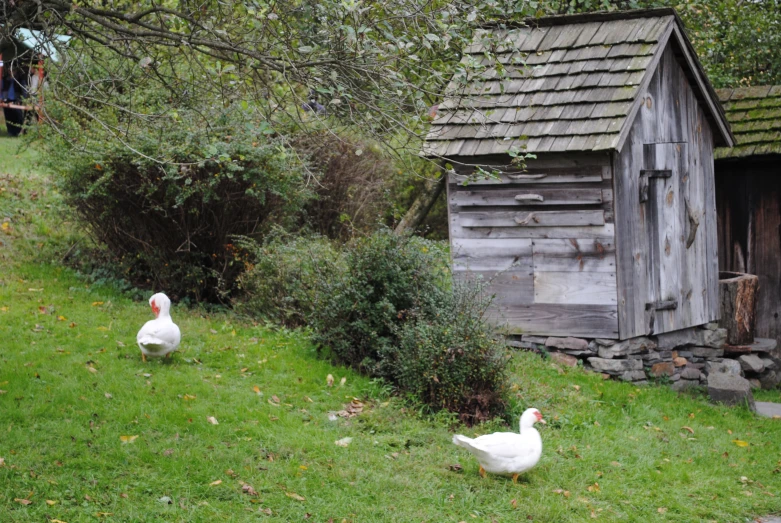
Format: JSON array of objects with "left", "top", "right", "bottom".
[{"left": 716, "top": 85, "right": 781, "bottom": 341}]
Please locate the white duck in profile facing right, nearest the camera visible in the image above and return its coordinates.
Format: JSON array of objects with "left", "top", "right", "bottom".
[{"left": 453, "top": 409, "right": 545, "bottom": 483}]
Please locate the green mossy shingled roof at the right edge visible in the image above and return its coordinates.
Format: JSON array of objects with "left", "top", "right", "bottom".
[{"left": 715, "top": 85, "right": 781, "bottom": 159}]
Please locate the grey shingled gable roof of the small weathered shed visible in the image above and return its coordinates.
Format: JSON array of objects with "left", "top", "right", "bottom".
[{"left": 423, "top": 9, "right": 731, "bottom": 157}]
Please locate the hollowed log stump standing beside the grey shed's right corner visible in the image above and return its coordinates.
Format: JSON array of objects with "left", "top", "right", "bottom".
[{"left": 719, "top": 272, "right": 759, "bottom": 345}]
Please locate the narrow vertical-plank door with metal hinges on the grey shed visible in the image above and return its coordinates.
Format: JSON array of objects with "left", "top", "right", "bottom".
[{"left": 639, "top": 143, "right": 706, "bottom": 334}]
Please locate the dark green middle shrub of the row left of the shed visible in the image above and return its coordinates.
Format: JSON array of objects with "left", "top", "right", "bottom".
[{"left": 310, "top": 233, "right": 449, "bottom": 376}]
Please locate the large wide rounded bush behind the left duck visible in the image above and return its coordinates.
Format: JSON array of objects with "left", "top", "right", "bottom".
[{"left": 42, "top": 108, "right": 311, "bottom": 302}]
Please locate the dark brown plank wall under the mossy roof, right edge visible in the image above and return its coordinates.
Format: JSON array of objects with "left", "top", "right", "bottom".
[{"left": 716, "top": 168, "right": 781, "bottom": 341}]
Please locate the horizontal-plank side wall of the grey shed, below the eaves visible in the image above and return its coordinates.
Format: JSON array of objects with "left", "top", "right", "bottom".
[{"left": 448, "top": 153, "right": 618, "bottom": 338}]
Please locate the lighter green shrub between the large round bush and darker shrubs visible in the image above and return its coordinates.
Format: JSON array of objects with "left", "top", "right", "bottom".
[{"left": 236, "top": 235, "right": 345, "bottom": 327}]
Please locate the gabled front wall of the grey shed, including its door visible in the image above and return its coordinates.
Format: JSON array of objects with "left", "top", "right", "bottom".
[{"left": 614, "top": 43, "right": 718, "bottom": 338}]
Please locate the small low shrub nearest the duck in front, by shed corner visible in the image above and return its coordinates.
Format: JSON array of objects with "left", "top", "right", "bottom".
[{"left": 382, "top": 282, "right": 507, "bottom": 425}]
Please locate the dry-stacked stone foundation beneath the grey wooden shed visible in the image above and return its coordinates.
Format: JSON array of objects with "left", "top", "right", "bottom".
[{"left": 507, "top": 323, "right": 781, "bottom": 390}]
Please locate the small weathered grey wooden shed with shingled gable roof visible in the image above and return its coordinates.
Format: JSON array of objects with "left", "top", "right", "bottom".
[{"left": 424, "top": 9, "right": 733, "bottom": 339}]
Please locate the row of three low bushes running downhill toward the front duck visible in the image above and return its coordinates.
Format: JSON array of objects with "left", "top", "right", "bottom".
[{"left": 241, "top": 230, "right": 507, "bottom": 423}]
